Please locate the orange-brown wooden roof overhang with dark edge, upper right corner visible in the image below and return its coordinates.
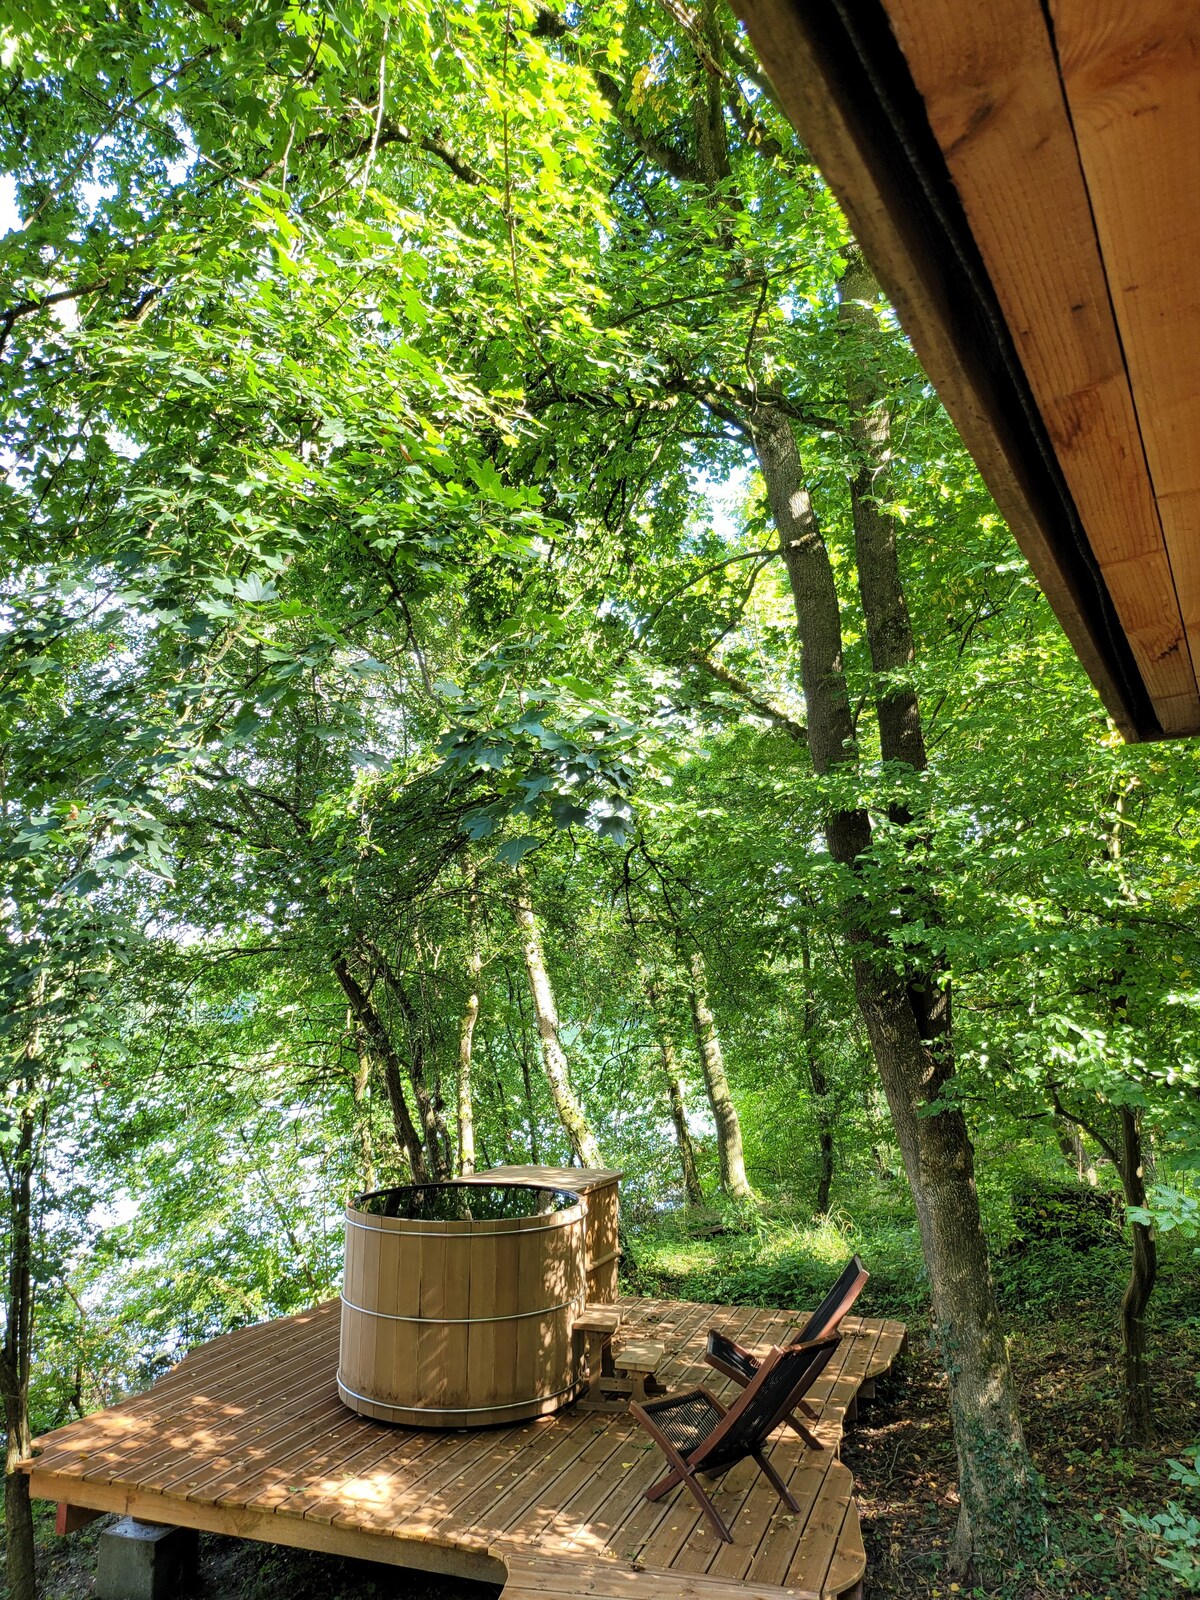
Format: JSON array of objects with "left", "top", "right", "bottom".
[{"left": 734, "top": 0, "right": 1200, "bottom": 741}]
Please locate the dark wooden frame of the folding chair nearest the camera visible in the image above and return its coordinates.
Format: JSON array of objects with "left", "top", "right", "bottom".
[{"left": 629, "top": 1334, "right": 842, "bottom": 1544}]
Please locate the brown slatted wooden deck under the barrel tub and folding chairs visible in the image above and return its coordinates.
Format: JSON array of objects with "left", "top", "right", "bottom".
[{"left": 27, "top": 1299, "right": 904, "bottom": 1600}]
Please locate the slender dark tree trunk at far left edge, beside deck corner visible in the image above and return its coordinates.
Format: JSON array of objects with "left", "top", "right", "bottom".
[{"left": 0, "top": 1107, "right": 37, "bottom": 1600}]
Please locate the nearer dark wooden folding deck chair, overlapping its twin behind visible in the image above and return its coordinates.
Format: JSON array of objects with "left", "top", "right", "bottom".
[{"left": 629, "top": 1334, "right": 840, "bottom": 1544}]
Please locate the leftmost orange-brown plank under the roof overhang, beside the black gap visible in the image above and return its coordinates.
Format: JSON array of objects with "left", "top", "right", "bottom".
[{"left": 883, "top": 0, "right": 1200, "bottom": 734}]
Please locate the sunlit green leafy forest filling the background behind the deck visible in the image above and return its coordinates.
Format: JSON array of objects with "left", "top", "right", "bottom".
[{"left": 0, "top": 0, "right": 1200, "bottom": 1600}]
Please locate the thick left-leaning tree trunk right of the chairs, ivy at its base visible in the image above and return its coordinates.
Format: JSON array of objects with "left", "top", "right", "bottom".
[{"left": 754, "top": 406, "right": 1045, "bottom": 1578}]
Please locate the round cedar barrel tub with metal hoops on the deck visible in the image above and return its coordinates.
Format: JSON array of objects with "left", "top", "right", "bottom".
[{"left": 338, "top": 1181, "right": 587, "bottom": 1427}]
